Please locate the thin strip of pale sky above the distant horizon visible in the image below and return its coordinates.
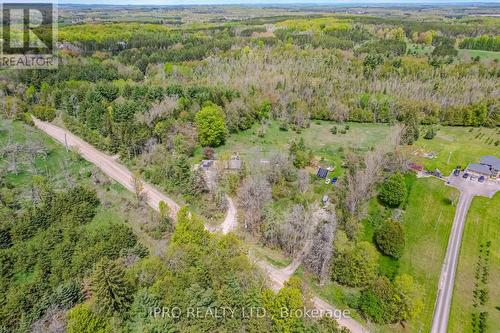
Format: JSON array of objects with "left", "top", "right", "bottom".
[{"left": 6, "top": 0, "right": 500, "bottom": 5}]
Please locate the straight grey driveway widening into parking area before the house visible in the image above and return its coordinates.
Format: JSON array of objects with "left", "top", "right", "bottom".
[{"left": 431, "top": 175, "right": 500, "bottom": 333}]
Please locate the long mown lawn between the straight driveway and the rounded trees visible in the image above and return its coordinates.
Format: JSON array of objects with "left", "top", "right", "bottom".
[{"left": 398, "top": 178, "right": 457, "bottom": 332}]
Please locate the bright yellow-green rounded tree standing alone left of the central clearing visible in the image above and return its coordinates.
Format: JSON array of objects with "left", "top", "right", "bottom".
[{"left": 195, "top": 104, "right": 227, "bottom": 147}]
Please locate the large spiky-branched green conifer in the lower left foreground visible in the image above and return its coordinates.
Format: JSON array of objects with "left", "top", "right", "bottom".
[{"left": 92, "top": 257, "right": 132, "bottom": 312}]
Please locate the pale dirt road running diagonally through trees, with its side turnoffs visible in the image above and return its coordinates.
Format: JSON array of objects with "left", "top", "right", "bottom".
[{"left": 33, "top": 119, "right": 368, "bottom": 333}]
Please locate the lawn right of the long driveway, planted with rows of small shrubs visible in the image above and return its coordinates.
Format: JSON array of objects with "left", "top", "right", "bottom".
[{"left": 448, "top": 193, "right": 500, "bottom": 333}]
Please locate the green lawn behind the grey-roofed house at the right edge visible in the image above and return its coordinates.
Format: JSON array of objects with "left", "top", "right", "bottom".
[{"left": 410, "top": 126, "right": 500, "bottom": 175}]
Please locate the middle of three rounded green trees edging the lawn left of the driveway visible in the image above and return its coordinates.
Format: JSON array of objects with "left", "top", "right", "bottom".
[{"left": 375, "top": 219, "right": 405, "bottom": 258}]
